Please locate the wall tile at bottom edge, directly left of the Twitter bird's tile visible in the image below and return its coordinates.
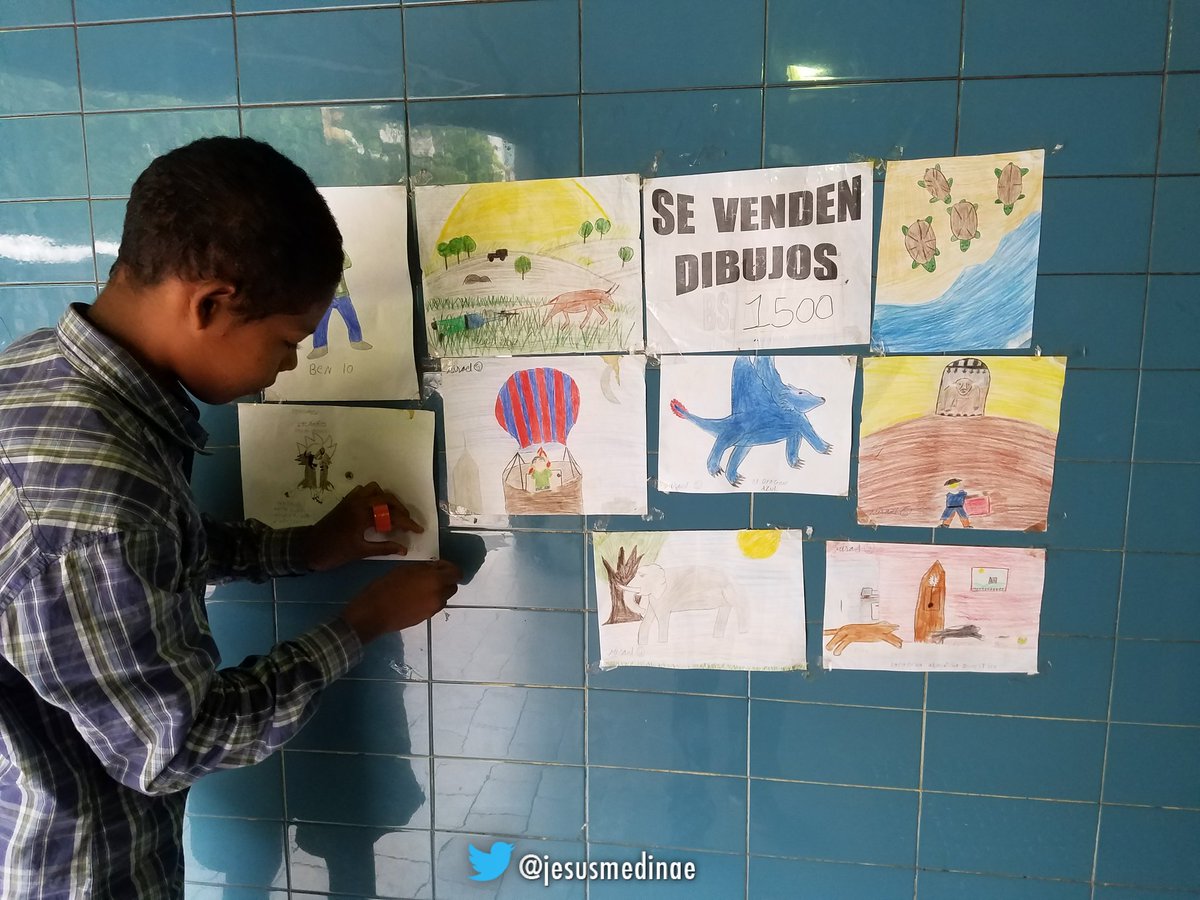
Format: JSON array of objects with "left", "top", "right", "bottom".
[{"left": 288, "top": 822, "right": 433, "bottom": 900}]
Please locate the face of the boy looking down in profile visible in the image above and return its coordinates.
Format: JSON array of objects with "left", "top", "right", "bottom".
[{"left": 181, "top": 301, "right": 329, "bottom": 403}]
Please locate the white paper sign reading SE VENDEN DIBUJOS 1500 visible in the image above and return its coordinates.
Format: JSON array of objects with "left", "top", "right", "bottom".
[{"left": 642, "top": 163, "right": 872, "bottom": 353}]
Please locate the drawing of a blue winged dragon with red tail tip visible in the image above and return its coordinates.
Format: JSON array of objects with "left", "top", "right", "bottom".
[{"left": 658, "top": 356, "right": 858, "bottom": 497}]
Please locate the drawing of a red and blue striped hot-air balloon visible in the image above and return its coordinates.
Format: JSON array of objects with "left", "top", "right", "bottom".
[{"left": 428, "top": 356, "right": 646, "bottom": 527}]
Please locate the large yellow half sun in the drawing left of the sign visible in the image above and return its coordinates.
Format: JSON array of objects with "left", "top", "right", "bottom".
[{"left": 433, "top": 179, "right": 608, "bottom": 262}]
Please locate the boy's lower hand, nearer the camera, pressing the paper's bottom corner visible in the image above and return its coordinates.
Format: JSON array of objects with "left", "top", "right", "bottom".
[{"left": 342, "top": 559, "right": 462, "bottom": 643}]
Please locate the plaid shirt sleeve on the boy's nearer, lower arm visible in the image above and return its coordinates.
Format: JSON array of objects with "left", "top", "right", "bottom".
[{"left": 0, "top": 530, "right": 362, "bottom": 794}]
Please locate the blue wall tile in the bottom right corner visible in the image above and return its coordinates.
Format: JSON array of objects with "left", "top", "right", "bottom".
[{"left": 1096, "top": 806, "right": 1200, "bottom": 892}]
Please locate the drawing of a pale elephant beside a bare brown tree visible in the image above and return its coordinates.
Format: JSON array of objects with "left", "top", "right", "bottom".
[{"left": 592, "top": 530, "right": 805, "bottom": 670}]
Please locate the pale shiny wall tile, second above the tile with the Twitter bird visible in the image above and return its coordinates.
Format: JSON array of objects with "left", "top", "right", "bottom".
[{"left": 432, "top": 684, "right": 583, "bottom": 766}]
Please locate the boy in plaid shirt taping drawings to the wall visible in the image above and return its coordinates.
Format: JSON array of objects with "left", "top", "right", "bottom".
[{"left": 0, "top": 138, "right": 458, "bottom": 900}]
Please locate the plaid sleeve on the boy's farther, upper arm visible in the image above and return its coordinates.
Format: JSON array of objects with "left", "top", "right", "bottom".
[{"left": 200, "top": 515, "right": 310, "bottom": 581}]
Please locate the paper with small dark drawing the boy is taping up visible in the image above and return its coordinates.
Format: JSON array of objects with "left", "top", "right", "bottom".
[{"left": 238, "top": 403, "right": 438, "bottom": 559}]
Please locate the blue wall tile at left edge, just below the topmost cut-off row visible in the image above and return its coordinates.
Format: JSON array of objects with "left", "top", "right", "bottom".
[{"left": 0, "top": 28, "right": 79, "bottom": 114}]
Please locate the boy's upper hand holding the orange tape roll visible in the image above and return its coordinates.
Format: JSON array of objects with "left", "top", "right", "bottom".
[{"left": 305, "top": 481, "right": 425, "bottom": 572}]
